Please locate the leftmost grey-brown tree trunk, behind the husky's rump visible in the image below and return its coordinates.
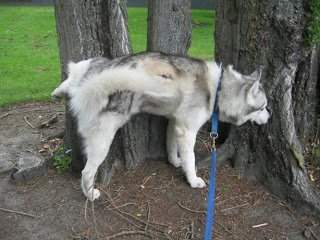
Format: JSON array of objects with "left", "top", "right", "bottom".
[{"left": 55, "top": 0, "right": 136, "bottom": 181}]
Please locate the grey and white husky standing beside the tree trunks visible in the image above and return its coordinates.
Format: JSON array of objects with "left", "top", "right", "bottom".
[{"left": 52, "top": 52, "right": 270, "bottom": 201}]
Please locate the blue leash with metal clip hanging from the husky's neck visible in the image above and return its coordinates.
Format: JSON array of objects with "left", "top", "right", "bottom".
[{"left": 204, "top": 72, "right": 223, "bottom": 240}]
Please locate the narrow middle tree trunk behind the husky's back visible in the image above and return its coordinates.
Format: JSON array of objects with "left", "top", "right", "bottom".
[{"left": 145, "top": 0, "right": 192, "bottom": 158}]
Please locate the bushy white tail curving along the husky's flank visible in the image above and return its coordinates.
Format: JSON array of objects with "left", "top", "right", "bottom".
[{"left": 70, "top": 66, "right": 178, "bottom": 117}]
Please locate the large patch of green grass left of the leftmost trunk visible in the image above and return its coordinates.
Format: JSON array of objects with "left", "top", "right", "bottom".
[{"left": 0, "top": 6, "right": 60, "bottom": 106}]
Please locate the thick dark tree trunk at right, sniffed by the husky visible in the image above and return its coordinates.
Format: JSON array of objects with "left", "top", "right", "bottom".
[{"left": 216, "top": 0, "right": 320, "bottom": 213}]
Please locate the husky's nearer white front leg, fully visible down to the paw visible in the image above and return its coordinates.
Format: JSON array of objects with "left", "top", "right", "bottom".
[{"left": 177, "top": 129, "right": 206, "bottom": 188}]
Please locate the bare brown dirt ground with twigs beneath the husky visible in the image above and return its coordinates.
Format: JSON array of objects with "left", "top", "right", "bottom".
[{"left": 0, "top": 103, "right": 320, "bottom": 240}]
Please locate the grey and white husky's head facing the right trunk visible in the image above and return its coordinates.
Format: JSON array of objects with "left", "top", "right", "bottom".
[{"left": 219, "top": 66, "right": 270, "bottom": 126}]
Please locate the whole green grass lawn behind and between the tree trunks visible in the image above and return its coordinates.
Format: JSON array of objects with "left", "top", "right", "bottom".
[{"left": 0, "top": 6, "right": 214, "bottom": 106}]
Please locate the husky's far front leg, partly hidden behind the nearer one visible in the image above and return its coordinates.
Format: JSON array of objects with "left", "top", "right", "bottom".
[{"left": 167, "top": 119, "right": 181, "bottom": 167}]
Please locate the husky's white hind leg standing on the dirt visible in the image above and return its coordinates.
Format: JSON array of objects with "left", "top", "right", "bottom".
[{"left": 81, "top": 113, "right": 125, "bottom": 201}]
